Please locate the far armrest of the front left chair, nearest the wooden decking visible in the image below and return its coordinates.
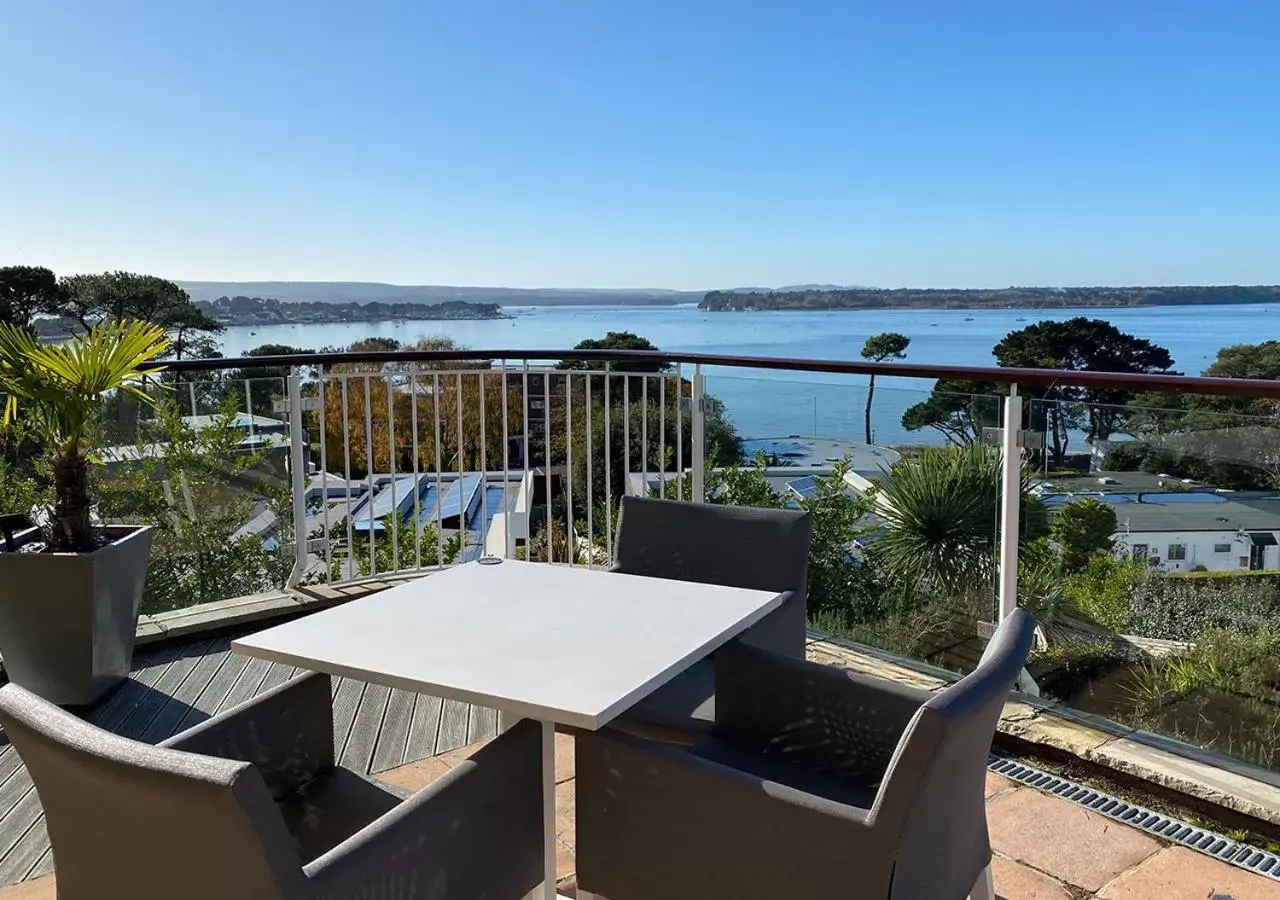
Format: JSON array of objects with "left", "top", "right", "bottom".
[{"left": 160, "top": 672, "right": 334, "bottom": 799}]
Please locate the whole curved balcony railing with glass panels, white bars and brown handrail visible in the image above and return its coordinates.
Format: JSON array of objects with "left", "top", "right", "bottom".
[{"left": 64, "top": 350, "right": 1280, "bottom": 783}]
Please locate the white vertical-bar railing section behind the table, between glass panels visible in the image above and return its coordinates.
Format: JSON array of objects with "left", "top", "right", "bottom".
[{"left": 277, "top": 361, "right": 705, "bottom": 585}]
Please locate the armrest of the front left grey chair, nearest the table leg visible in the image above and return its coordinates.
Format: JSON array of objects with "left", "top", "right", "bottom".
[{"left": 303, "top": 719, "right": 543, "bottom": 900}]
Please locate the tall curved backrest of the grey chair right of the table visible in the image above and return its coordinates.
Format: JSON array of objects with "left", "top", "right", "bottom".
[{"left": 876, "top": 609, "right": 1036, "bottom": 897}]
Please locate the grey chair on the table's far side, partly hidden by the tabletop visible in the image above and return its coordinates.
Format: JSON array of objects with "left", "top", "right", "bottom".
[{"left": 613, "top": 497, "right": 813, "bottom": 744}]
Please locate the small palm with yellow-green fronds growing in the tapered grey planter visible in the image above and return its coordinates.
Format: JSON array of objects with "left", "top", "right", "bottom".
[{"left": 0, "top": 321, "right": 169, "bottom": 553}]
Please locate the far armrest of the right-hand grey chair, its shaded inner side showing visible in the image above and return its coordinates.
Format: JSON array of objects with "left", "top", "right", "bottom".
[{"left": 714, "top": 641, "right": 933, "bottom": 783}]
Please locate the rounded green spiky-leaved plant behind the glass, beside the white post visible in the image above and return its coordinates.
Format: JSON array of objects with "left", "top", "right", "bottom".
[{"left": 874, "top": 443, "right": 1048, "bottom": 594}]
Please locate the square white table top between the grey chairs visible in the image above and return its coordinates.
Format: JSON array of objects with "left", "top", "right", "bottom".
[{"left": 232, "top": 559, "right": 782, "bottom": 728}]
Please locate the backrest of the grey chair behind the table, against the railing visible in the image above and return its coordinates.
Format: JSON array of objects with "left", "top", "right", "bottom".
[{"left": 614, "top": 497, "right": 813, "bottom": 655}]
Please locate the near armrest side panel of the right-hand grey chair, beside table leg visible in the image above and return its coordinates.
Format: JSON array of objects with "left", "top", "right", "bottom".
[{"left": 575, "top": 730, "right": 892, "bottom": 897}]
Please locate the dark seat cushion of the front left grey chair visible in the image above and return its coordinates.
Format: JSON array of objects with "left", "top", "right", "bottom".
[{"left": 276, "top": 768, "right": 402, "bottom": 865}]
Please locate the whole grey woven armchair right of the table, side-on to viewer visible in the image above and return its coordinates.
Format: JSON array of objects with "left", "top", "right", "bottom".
[{"left": 575, "top": 611, "right": 1034, "bottom": 900}]
